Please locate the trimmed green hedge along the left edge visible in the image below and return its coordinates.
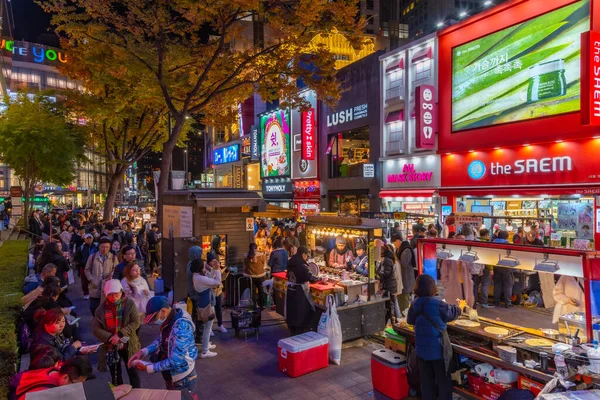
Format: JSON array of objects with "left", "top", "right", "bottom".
[{"left": 0, "top": 240, "right": 29, "bottom": 399}]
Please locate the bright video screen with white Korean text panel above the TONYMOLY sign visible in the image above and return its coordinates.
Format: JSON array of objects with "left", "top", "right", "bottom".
[{"left": 260, "top": 110, "right": 291, "bottom": 177}]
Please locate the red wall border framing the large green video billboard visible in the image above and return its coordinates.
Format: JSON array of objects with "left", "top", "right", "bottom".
[{"left": 438, "top": 0, "right": 600, "bottom": 153}]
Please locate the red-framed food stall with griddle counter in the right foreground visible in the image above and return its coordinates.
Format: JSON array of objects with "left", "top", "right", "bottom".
[{"left": 394, "top": 239, "right": 600, "bottom": 399}]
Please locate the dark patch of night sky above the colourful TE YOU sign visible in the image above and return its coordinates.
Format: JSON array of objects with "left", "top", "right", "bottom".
[{"left": 11, "top": 0, "right": 58, "bottom": 46}]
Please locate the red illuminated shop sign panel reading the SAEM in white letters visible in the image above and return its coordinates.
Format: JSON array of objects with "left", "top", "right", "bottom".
[{"left": 442, "top": 139, "right": 600, "bottom": 188}]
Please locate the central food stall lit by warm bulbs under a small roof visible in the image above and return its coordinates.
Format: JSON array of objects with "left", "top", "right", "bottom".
[{"left": 272, "top": 215, "right": 388, "bottom": 341}]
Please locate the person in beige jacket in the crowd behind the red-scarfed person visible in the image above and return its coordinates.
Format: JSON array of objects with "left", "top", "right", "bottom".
[{"left": 85, "top": 237, "right": 119, "bottom": 315}]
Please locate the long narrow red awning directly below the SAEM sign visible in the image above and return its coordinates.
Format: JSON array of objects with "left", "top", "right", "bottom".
[{"left": 440, "top": 185, "right": 600, "bottom": 197}]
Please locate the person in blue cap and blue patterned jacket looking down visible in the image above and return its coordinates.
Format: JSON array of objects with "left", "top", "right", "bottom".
[{"left": 127, "top": 296, "right": 198, "bottom": 399}]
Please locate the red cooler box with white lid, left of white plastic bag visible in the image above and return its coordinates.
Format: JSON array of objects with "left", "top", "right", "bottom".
[{"left": 277, "top": 332, "right": 329, "bottom": 378}]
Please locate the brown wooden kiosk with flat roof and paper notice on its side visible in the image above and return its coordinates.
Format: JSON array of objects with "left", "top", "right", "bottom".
[{"left": 158, "top": 189, "right": 265, "bottom": 304}]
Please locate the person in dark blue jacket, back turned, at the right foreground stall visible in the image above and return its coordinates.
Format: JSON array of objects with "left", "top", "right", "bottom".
[{"left": 406, "top": 274, "right": 466, "bottom": 400}]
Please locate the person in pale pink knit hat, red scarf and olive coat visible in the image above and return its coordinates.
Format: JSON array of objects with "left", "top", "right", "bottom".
[{"left": 93, "top": 279, "right": 141, "bottom": 388}]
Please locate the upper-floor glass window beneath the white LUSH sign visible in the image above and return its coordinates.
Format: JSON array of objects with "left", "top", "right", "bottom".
[{"left": 327, "top": 126, "right": 370, "bottom": 178}]
